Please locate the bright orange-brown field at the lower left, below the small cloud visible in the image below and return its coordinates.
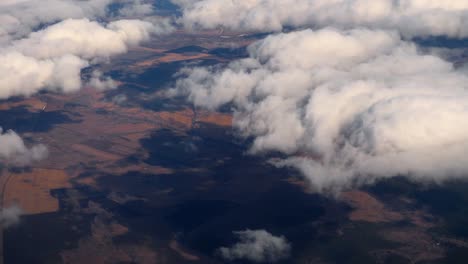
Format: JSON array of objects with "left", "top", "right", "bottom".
[{"left": 3, "top": 168, "right": 71, "bottom": 214}]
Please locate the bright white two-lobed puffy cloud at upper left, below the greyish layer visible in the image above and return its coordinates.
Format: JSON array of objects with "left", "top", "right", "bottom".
[{"left": 0, "top": 19, "right": 157, "bottom": 98}]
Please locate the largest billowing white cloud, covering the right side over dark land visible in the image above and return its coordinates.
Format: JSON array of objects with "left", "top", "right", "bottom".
[{"left": 171, "top": 29, "right": 468, "bottom": 192}]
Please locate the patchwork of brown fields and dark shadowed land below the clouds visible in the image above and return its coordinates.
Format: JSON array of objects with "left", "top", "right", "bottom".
[{"left": 0, "top": 31, "right": 468, "bottom": 263}]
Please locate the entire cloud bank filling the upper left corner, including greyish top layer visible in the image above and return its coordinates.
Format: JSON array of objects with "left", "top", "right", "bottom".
[{"left": 0, "top": 0, "right": 172, "bottom": 99}]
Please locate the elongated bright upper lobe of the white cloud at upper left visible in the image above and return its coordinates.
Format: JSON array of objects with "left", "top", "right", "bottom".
[{"left": 9, "top": 19, "right": 152, "bottom": 59}]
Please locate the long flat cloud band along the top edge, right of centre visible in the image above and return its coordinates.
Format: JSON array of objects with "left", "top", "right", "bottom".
[{"left": 172, "top": 0, "right": 468, "bottom": 37}]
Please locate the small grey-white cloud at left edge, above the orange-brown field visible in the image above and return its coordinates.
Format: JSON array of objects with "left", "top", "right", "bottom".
[{"left": 0, "top": 128, "right": 48, "bottom": 166}]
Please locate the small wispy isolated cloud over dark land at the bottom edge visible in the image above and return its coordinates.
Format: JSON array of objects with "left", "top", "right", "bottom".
[{"left": 218, "top": 230, "right": 291, "bottom": 263}]
